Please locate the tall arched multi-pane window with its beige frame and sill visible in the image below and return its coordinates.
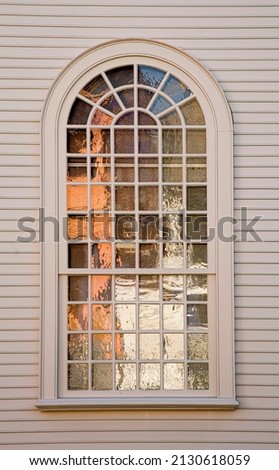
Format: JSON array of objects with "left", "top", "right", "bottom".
[{"left": 38, "top": 40, "right": 237, "bottom": 409}]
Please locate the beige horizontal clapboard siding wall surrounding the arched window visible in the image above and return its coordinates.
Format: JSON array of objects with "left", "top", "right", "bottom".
[{"left": 0, "top": 0, "right": 279, "bottom": 449}]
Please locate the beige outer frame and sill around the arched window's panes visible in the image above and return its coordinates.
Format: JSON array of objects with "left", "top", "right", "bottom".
[{"left": 36, "top": 39, "right": 238, "bottom": 410}]
